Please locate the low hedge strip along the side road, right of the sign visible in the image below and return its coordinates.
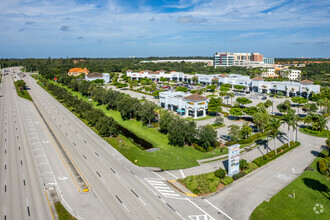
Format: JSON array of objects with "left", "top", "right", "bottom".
[{"left": 252, "top": 141, "right": 300, "bottom": 167}]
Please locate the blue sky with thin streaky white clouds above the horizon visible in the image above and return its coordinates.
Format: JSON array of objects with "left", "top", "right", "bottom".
[{"left": 0, "top": 0, "right": 330, "bottom": 58}]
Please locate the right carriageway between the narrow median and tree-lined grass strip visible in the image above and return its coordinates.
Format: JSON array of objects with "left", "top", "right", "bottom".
[{"left": 25, "top": 69, "right": 219, "bottom": 219}]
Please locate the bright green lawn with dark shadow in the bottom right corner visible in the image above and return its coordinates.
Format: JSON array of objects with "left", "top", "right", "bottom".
[{"left": 251, "top": 150, "right": 330, "bottom": 220}]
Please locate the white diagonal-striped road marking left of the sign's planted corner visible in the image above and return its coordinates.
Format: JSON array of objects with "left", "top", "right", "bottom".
[{"left": 144, "top": 178, "right": 185, "bottom": 200}]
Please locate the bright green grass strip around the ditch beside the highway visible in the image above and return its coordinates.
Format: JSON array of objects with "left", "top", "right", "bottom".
[{"left": 45, "top": 81, "right": 228, "bottom": 170}]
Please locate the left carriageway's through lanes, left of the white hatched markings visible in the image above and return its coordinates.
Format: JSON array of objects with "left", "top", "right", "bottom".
[{"left": 0, "top": 69, "right": 53, "bottom": 220}]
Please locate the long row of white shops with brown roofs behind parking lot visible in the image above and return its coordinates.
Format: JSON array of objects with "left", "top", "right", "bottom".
[{"left": 126, "top": 69, "right": 320, "bottom": 97}]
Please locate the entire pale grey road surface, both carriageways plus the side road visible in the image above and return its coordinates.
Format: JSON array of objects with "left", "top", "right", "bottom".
[{"left": 0, "top": 68, "right": 321, "bottom": 220}]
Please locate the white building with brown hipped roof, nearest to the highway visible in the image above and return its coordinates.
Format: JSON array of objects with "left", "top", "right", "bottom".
[{"left": 159, "top": 91, "right": 209, "bottom": 118}]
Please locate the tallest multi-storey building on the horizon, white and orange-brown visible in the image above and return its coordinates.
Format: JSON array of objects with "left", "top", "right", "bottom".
[{"left": 213, "top": 52, "right": 274, "bottom": 67}]
